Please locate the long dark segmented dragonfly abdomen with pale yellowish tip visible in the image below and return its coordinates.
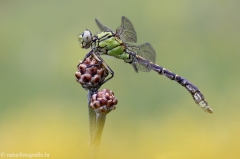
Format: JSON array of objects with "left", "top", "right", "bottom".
[{"left": 151, "top": 63, "right": 213, "bottom": 113}]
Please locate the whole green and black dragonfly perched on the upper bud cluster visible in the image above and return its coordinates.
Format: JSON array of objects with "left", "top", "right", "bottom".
[{"left": 78, "top": 16, "right": 213, "bottom": 113}]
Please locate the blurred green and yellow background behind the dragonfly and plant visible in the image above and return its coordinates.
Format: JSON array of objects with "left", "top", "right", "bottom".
[{"left": 0, "top": 0, "right": 240, "bottom": 159}]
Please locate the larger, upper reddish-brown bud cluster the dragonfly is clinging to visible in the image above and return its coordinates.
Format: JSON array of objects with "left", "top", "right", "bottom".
[{"left": 75, "top": 56, "right": 108, "bottom": 90}]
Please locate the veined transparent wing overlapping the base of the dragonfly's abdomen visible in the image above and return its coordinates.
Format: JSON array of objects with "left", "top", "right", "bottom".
[{"left": 127, "top": 43, "right": 156, "bottom": 72}]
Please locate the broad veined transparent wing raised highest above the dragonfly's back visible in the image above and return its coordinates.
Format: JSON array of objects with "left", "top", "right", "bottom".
[{"left": 116, "top": 16, "right": 137, "bottom": 43}]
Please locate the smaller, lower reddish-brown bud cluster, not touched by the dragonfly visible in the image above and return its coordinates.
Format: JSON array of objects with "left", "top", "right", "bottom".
[{"left": 90, "top": 89, "right": 118, "bottom": 114}]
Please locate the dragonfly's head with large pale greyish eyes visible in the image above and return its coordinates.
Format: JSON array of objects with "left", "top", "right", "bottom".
[{"left": 78, "top": 30, "right": 92, "bottom": 49}]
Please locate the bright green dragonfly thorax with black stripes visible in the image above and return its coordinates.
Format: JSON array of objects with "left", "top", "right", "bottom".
[{"left": 95, "top": 32, "right": 129, "bottom": 60}]
